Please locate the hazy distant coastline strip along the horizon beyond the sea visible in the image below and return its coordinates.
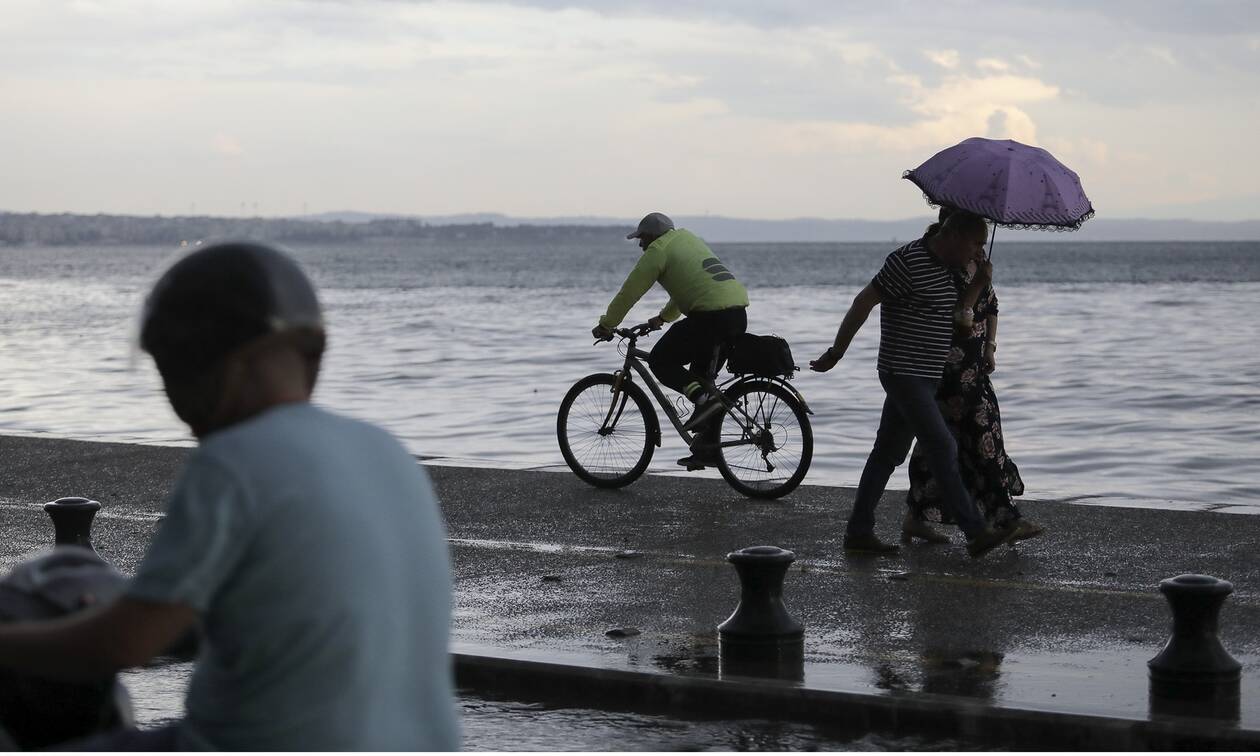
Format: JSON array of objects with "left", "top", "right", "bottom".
[{"left": 0, "top": 212, "right": 1260, "bottom": 247}]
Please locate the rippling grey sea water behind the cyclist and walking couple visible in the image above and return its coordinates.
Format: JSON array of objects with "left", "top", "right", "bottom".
[{"left": 0, "top": 240, "right": 1260, "bottom": 512}]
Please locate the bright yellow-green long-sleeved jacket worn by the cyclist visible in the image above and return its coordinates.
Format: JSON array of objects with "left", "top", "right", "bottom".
[{"left": 600, "top": 228, "right": 748, "bottom": 328}]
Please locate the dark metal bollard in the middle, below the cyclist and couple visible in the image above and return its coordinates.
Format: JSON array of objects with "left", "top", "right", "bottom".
[{"left": 717, "top": 546, "right": 805, "bottom": 680}]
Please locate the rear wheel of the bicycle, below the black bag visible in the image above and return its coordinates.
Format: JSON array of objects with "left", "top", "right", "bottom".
[{"left": 716, "top": 381, "right": 814, "bottom": 499}]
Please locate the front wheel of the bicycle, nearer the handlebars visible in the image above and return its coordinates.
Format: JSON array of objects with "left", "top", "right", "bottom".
[{"left": 556, "top": 373, "right": 656, "bottom": 488}]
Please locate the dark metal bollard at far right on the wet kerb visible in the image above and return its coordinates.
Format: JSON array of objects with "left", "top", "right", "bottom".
[{"left": 1147, "top": 575, "right": 1242, "bottom": 718}]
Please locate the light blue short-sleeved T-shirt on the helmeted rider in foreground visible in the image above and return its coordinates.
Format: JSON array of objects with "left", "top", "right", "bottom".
[{"left": 127, "top": 403, "right": 459, "bottom": 751}]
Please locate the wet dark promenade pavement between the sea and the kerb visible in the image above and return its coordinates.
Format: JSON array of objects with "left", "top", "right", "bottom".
[{"left": 0, "top": 437, "right": 1260, "bottom": 745}]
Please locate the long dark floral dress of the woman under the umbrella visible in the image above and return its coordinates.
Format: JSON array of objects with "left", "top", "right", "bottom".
[{"left": 906, "top": 267, "right": 1023, "bottom": 527}]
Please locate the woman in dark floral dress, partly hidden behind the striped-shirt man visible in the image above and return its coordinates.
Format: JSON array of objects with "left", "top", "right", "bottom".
[{"left": 901, "top": 205, "right": 1043, "bottom": 543}]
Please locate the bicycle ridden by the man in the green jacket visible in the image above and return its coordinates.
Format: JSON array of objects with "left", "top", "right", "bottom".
[{"left": 556, "top": 324, "right": 814, "bottom": 499}]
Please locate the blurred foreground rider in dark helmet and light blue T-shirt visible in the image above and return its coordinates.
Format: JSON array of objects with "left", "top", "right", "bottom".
[{"left": 0, "top": 243, "right": 459, "bottom": 751}]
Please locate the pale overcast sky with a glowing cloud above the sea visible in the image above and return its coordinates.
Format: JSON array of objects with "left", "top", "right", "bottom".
[{"left": 0, "top": 0, "right": 1260, "bottom": 219}]
